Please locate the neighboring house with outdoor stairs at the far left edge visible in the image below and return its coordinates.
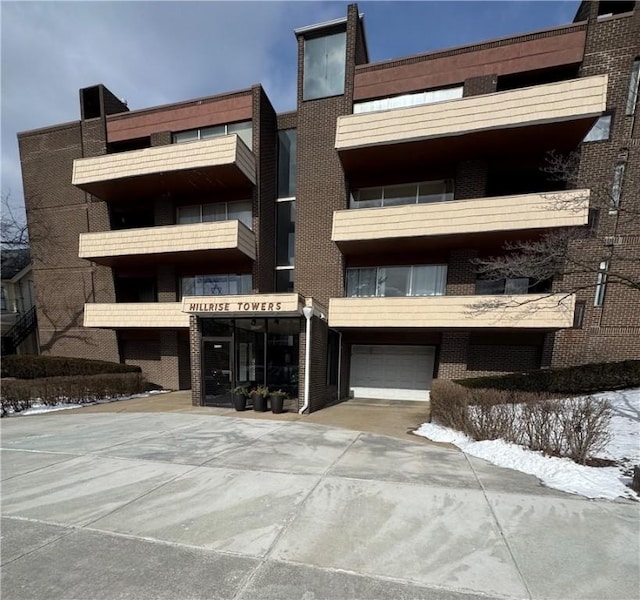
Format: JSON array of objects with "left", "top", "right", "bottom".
[{"left": 0, "top": 249, "right": 38, "bottom": 355}]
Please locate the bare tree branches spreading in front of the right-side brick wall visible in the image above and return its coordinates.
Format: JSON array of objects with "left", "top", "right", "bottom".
[{"left": 473, "top": 152, "right": 640, "bottom": 310}]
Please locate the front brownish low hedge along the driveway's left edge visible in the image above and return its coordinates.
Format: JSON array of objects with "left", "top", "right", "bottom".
[{"left": 0, "top": 373, "right": 146, "bottom": 417}]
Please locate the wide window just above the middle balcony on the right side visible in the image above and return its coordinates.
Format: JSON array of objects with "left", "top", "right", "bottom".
[{"left": 351, "top": 179, "right": 453, "bottom": 208}]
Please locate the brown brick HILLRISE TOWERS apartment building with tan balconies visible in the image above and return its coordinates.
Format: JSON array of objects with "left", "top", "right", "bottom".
[{"left": 19, "top": 2, "right": 640, "bottom": 410}]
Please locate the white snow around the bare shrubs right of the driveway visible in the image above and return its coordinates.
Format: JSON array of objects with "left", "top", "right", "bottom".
[{"left": 413, "top": 388, "right": 640, "bottom": 500}]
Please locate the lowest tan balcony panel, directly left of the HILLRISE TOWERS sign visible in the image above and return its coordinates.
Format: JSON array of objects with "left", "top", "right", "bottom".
[{"left": 84, "top": 302, "right": 189, "bottom": 329}]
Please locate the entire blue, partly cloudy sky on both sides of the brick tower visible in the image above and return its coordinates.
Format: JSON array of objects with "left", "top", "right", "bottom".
[{"left": 0, "top": 0, "right": 579, "bottom": 217}]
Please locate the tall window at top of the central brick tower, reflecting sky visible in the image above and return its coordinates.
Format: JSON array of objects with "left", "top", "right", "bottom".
[{"left": 302, "top": 32, "right": 347, "bottom": 100}]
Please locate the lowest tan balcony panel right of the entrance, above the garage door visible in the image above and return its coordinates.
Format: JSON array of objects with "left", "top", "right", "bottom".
[{"left": 329, "top": 294, "right": 575, "bottom": 329}]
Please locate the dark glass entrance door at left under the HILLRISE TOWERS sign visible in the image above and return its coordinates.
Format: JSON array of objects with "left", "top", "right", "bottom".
[{"left": 202, "top": 338, "right": 233, "bottom": 406}]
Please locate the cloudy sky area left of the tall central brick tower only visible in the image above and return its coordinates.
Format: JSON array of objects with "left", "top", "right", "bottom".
[{"left": 1, "top": 2, "right": 346, "bottom": 210}]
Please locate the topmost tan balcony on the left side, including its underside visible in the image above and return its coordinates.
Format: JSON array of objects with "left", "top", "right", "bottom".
[{"left": 71, "top": 135, "right": 256, "bottom": 201}]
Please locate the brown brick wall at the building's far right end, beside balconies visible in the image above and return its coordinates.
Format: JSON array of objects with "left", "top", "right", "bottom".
[{"left": 551, "top": 8, "right": 640, "bottom": 366}]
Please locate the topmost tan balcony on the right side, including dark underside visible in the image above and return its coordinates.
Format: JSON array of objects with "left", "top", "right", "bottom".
[{"left": 335, "top": 75, "right": 607, "bottom": 173}]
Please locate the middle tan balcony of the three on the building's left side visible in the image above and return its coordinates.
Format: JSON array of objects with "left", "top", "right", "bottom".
[{"left": 78, "top": 221, "right": 256, "bottom": 266}]
